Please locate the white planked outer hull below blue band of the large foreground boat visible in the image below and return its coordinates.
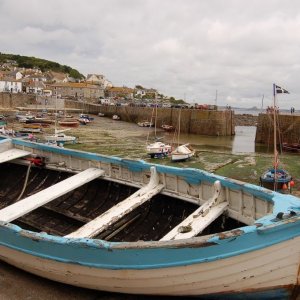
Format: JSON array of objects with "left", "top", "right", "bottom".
[{"left": 0, "top": 238, "right": 300, "bottom": 296}]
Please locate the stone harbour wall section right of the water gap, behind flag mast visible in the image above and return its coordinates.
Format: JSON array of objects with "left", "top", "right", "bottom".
[{"left": 255, "top": 114, "right": 300, "bottom": 145}]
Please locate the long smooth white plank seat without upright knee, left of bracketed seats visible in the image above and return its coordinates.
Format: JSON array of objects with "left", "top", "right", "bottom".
[{"left": 0, "top": 168, "right": 105, "bottom": 222}]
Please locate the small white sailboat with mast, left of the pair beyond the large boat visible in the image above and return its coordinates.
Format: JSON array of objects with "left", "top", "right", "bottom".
[{"left": 146, "top": 101, "right": 172, "bottom": 158}]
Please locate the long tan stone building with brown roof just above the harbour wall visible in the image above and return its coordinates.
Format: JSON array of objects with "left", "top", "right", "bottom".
[{"left": 47, "top": 82, "right": 104, "bottom": 100}]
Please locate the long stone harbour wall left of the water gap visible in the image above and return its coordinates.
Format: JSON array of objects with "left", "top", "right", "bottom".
[{"left": 66, "top": 101, "right": 235, "bottom": 136}]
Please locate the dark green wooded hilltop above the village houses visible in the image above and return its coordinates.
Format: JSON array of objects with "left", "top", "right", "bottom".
[{"left": 0, "top": 53, "right": 84, "bottom": 79}]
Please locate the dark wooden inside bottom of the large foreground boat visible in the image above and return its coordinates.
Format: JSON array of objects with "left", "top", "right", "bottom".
[{"left": 0, "top": 162, "right": 245, "bottom": 242}]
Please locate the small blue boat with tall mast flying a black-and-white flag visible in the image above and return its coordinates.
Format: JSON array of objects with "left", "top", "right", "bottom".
[{"left": 260, "top": 84, "right": 294, "bottom": 192}]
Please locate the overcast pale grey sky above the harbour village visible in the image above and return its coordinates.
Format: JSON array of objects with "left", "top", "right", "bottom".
[{"left": 0, "top": 0, "right": 300, "bottom": 109}]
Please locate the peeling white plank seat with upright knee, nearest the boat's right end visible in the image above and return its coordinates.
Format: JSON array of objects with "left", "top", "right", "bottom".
[{"left": 161, "top": 181, "right": 228, "bottom": 241}]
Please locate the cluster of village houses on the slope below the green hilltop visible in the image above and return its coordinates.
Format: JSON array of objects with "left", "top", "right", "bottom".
[{"left": 0, "top": 59, "right": 183, "bottom": 105}]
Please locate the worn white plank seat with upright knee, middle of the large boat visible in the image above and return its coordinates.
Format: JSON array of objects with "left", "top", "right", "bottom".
[{"left": 66, "top": 167, "right": 164, "bottom": 238}]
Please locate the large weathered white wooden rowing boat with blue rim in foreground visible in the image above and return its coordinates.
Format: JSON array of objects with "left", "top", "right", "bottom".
[{"left": 0, "top": 138, "right": 300, "bottom": 299}]
